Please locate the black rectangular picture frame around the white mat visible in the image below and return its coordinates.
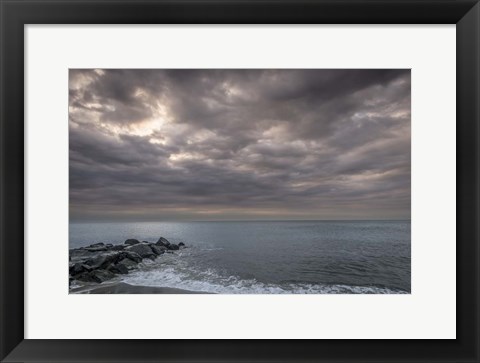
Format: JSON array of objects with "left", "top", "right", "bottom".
[{"left": 0, "top": 0, "right": 480, "bottom": 362}]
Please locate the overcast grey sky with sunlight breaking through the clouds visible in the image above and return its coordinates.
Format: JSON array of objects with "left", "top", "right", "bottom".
[{"left": 69, "top": 69, "right": 411, "bottom": 221}]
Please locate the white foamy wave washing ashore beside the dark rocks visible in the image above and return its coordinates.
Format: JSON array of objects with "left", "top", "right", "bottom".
[{"left": 123, "top": 263, "right": 408, "bottom": 294}]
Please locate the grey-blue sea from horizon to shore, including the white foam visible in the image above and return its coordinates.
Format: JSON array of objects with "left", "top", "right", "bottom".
[{"left": 69, "top": 221, "right": 411, "bottom": 294}]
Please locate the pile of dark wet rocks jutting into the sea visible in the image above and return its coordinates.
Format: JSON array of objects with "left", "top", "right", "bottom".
[{"left": 69, "top": 237, "right": 185, "bottom": 285}]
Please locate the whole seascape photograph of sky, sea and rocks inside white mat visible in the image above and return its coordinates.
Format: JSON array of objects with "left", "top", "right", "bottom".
[{"left": 69, "top": 68, "right": 412, "bottom": 294}]
